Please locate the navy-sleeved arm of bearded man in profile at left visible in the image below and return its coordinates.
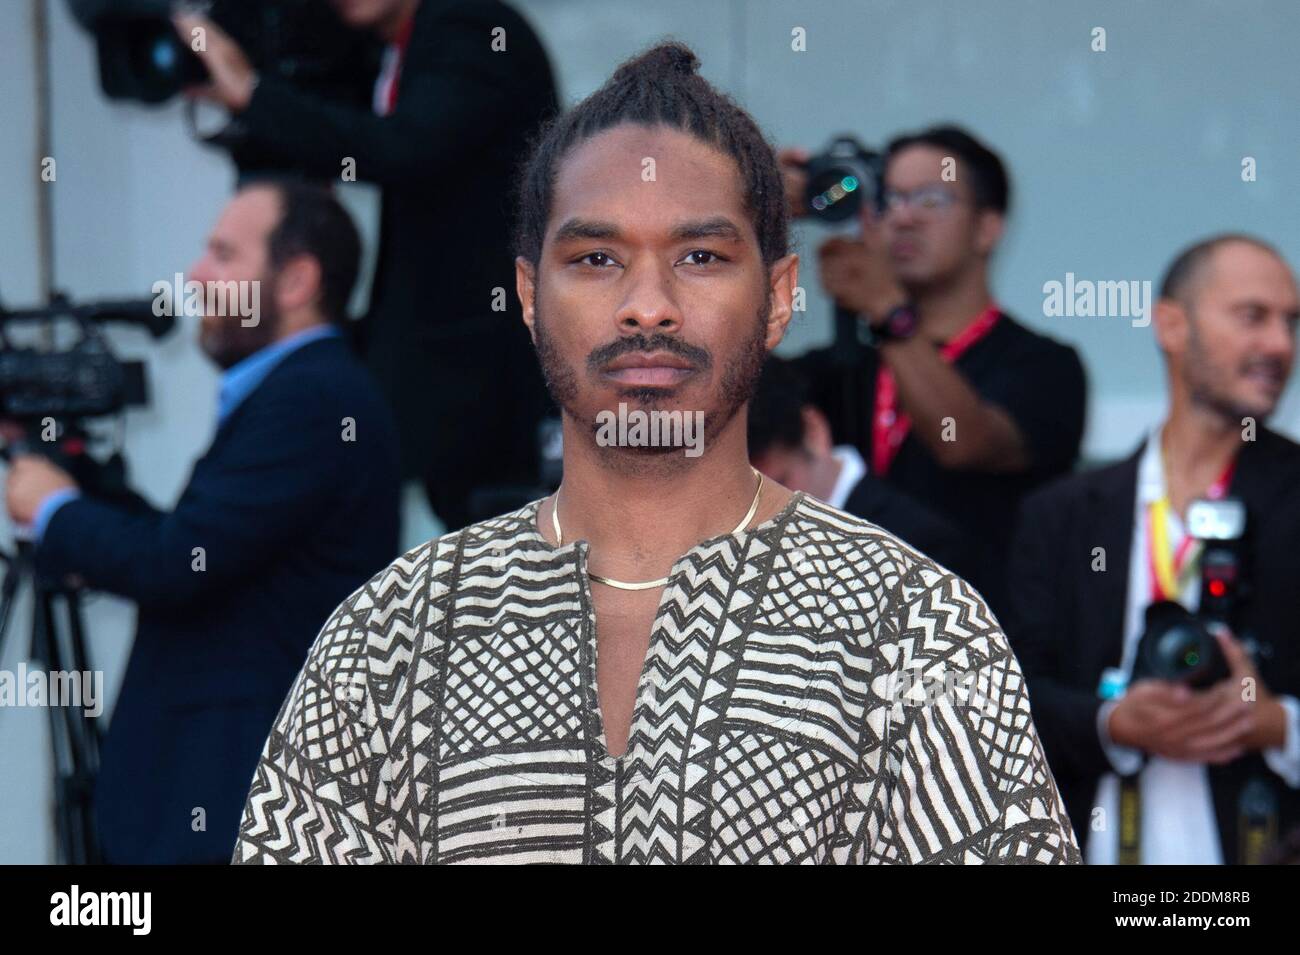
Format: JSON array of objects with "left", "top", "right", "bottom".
[{"left": 36, "top": 401, "right": 350, "bottom": 605}]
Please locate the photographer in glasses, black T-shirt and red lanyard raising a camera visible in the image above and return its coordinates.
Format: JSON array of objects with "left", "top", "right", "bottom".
[{"left": 783, "top": 126, "right": 1086, "bottom": 612}]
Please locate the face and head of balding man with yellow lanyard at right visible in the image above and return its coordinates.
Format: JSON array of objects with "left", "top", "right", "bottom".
[{"left": 1171, "top": 242, "right": 1300, "bottom": 420}]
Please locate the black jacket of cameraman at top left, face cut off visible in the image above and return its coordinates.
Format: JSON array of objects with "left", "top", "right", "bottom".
[{"left": 235, "top": 0, "right": 558, "bottom": 528}]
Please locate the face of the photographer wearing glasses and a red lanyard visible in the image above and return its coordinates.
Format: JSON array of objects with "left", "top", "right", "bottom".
[{"left": 883, "top": 146, "right": 1001, "bottom": 291}]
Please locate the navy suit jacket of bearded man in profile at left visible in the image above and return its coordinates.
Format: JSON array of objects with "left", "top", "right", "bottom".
[{"left": 36, "top": 338, "right": 400, "bottom": 863}]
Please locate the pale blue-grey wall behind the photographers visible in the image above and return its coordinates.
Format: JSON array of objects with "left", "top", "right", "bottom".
[{"left": 0, "top": 0, "right": 1300, "bottom": 863}]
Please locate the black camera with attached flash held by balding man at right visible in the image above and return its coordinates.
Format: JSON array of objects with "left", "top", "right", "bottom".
[{"left": 1132, "top": 498, "right": 1248, "bottom": 690}]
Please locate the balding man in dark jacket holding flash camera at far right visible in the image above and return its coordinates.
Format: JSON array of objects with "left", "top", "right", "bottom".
[{"left": 1008, "top": 235, "right": 1300, "bottom": 864}]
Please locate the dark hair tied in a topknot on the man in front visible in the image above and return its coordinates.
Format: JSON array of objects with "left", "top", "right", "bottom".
[{"left": 515, "top": 42, "right": 789, "bottom": 265}]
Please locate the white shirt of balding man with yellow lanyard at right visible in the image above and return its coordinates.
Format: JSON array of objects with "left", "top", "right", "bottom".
[{"left": 1086, "top": 427, "right": 1300, "bottom": 865}]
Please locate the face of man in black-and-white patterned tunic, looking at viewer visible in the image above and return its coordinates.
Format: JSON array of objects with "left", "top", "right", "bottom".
[{"left": 517, "top": 123, "right": 797, "bottom": 462}]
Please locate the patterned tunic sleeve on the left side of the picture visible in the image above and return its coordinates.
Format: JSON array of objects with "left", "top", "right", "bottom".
[{"left": 231, "top": 587, "right": 397, "bottom": 864}]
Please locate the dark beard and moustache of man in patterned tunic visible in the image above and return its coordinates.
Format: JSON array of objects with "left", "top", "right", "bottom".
[{"left": 533, "top": 286, "right": 772, "bottom": 456}]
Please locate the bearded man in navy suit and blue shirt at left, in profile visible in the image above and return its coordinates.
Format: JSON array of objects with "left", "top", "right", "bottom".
[{"left": 5, "top": 182, "right": 400, "bottom": 864}]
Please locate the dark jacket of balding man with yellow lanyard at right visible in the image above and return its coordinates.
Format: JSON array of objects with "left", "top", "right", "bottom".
[{"left": 1006, "top": 429, "right": 1300, "bottom": 863}]
